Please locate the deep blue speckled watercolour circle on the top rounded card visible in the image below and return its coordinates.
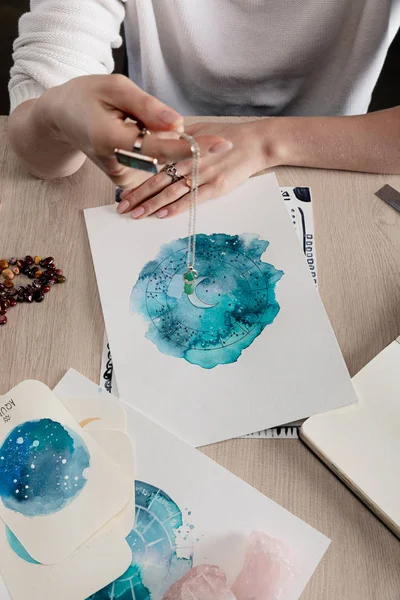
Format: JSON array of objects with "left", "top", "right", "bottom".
[{"left": 0, "top": 419, "right": 90, "bottom": 517}]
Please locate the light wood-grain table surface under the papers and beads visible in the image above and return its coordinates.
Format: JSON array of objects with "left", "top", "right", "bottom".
[{"left": 0, "top": 117, "right": 400, "bottom": 600}]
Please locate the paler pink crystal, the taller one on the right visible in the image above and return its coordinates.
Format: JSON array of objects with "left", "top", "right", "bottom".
[{"left": 232, "top": 531, "right": 295, "bottom": 600}]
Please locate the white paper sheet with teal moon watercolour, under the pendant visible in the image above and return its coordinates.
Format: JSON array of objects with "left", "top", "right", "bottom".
[{"left": 85, "top": 175, "right": 356, "bottom": 446}]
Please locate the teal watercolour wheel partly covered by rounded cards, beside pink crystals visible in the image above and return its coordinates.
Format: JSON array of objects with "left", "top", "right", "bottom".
[{"left": 88, "top": 481, "right": 193, "bottom": 600}]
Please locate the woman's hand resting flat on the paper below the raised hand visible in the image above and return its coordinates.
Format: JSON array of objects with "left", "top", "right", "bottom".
[{"left": 117, "top": 119, "right": 278, "bottom": 219}]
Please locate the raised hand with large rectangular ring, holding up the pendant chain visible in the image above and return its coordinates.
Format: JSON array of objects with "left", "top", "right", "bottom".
[{"left": 9, "top": 75, "right": 230, "bottom": 188}]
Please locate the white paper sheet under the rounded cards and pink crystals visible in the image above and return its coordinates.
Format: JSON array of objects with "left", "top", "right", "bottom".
[{"left": 49, "top": 371, "right": 329, "bottom": 600}]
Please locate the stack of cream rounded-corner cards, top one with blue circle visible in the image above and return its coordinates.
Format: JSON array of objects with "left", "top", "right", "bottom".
[{"left": 0, "top": 381, "right": 134, "bottom": 600}]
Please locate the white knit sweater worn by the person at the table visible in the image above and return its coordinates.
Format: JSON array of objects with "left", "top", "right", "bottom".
[{"left": 9, "top": 0, "right": 400, "bottom": 115}]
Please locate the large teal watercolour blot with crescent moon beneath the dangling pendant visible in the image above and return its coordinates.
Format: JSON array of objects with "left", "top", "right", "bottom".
[{"left": 130, "top": 233, "right": 284, "bottom": 369}]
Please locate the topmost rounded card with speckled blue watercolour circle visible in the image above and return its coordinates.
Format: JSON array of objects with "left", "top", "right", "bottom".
[{"left": 0, "top": 381, "right": 131, "bottom": 564}]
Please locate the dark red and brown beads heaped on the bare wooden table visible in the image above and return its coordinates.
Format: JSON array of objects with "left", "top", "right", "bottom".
[{"left": 0, "top": 255, "right": 66, "bottom": 325}]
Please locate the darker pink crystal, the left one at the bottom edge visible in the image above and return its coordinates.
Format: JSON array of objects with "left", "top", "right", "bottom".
[{"left": 163, "top": 565, "right": 236, "bottom": 600}]
